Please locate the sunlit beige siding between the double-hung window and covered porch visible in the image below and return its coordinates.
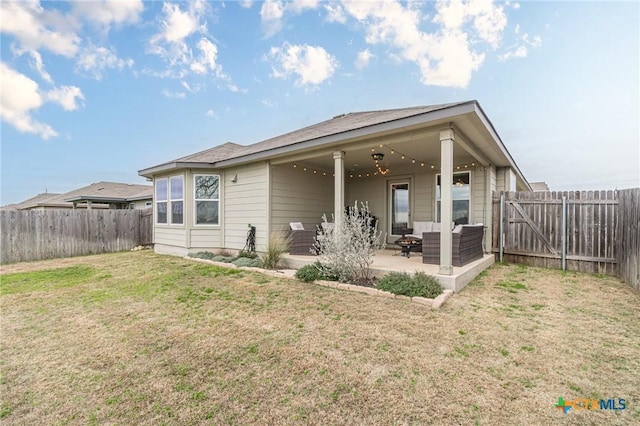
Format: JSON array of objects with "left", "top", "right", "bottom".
[{"left": 224, "top": 162, "right": 269, "bottom": 251}]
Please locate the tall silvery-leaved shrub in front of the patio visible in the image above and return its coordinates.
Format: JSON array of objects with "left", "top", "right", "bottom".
[{"left": 318, "top": 202, "right": 385, "bottom": 285}]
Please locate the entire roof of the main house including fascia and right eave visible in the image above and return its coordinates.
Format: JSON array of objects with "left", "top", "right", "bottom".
[{"left": 138, "top": 100, "right": 528, "bottom": 187}]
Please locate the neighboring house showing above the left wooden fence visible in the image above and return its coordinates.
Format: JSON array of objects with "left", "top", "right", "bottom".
[{"left": 3, "top": 182, "right": 153, "bottom": 210}]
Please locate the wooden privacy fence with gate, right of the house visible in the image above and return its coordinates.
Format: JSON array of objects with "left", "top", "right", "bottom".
[{"left": 492, "top": 188, "right": 640, "bottom": 289}]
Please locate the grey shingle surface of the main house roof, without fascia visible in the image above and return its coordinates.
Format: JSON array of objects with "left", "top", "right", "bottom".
[{"left": 154, "top": 101, "right": 473, "bottom": 164}]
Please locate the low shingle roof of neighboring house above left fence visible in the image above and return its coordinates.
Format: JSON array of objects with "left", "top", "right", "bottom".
[{"left": 3, "top": 182, "right": 153, "bottom": 210}]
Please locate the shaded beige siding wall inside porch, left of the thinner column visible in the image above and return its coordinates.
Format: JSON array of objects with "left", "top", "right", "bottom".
[{"left": 271, "top": 164, "right": 334, "bottom": 231}]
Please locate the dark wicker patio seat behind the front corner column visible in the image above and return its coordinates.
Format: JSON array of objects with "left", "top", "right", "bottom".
[{"left": 422, "top": 223, "right": 484, "bottom": 266}]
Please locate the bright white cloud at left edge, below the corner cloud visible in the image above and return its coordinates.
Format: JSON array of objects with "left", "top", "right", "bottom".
[{"left": 0, "top": 62, "right": 84, "bottom": 139}]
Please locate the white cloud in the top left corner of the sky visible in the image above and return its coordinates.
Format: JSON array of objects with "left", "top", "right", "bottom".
[{"left": 0, "top": 1, "right": 81, "bottom": 57}]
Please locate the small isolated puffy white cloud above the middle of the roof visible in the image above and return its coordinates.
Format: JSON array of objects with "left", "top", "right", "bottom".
[{"left": 268, "top": 43, "right": 338, "bottom": 87}]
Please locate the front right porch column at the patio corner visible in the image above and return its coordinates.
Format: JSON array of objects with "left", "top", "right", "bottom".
[{"left": 438, "top": 129, "right": 455, "bottom": 275}]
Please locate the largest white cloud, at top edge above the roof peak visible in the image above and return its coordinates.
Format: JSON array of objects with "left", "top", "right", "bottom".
[{"left": 342, "top": 0, "right": 506, "bottom": 87}]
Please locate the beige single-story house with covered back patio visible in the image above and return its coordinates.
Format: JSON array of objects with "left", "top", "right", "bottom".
[{"left": 139, "top": 100, "right": 531, "bottom": 280}]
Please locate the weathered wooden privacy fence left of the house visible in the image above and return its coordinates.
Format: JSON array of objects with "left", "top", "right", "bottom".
[{"left": 0, "top": 209, "right": 153, "bottom": 264}]
